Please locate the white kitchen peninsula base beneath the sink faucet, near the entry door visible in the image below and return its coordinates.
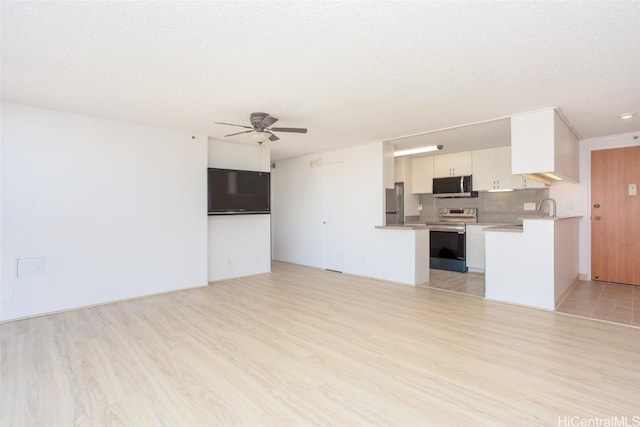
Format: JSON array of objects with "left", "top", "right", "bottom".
[{"left": 484, "top": 217, "right": 580, "bottom": 310}]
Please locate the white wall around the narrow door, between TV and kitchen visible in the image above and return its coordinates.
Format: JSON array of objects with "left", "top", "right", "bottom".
[{"left": 272, "top": 142, "right": 416, "bottom": 284}]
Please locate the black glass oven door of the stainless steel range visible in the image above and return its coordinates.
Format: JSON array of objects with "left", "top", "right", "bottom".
[{"left": 429, "top": 227, "right": 467, "bottom": 272}]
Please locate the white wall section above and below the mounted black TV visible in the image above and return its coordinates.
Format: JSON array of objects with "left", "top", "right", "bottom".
[{"left": 207, "top": 139, "right": 273, "bottom": 281}]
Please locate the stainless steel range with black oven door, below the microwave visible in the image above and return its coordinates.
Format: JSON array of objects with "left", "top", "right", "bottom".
[{"left": 427, "top": 208, "right": 478, "bottom": 273}]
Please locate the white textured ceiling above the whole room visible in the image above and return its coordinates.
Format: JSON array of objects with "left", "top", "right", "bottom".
[{"left": 1, "top": 1, "right": 640, "bottom": 159}]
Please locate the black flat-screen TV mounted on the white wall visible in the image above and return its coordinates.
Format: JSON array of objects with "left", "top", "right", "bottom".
[{"left": 208, "top": 168, "right": 271, "bottom": 215}]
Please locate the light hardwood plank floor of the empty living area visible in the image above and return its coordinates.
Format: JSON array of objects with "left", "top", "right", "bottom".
[{"left": 0, "top": 263, "right": 640, "bottom": 426}]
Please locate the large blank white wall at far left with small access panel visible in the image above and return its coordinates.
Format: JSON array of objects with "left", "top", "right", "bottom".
[{"left": 0, "top": 104, "right": 207, "bottom": 320}]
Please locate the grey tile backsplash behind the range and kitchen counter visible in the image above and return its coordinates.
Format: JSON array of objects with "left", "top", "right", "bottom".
[{"left": 419, "top": 188, "right": 549, "bottom": 223}]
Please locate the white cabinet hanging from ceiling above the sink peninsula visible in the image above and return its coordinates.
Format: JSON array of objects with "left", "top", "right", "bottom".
[{"left": 511, "top": 108, "right": 580, "bottom": 182}]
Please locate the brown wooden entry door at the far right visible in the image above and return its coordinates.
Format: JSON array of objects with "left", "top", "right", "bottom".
[{"left": 591, "top": 147, "right": 640, "bottom": 285}]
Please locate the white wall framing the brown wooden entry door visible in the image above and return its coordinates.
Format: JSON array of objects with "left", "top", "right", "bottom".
[{"left": 549, "top": 131, "right": 640, "bottom": 279}]
